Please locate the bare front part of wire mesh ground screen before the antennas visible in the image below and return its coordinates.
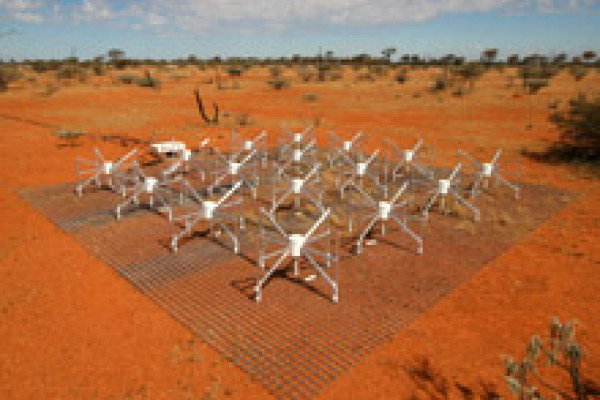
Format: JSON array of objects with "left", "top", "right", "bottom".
[{"left": 21, "top": 179, "right": 572, "bottom": 399}]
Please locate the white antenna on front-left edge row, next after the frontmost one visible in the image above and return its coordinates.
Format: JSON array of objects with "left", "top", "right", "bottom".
[{"left": 171, "top": 180, "right": 244, "bottom": 254}]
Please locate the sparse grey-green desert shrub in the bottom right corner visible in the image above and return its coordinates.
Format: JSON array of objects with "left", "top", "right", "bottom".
[{"left": 505, "top": 317, "right": 600, "bottom": 400}]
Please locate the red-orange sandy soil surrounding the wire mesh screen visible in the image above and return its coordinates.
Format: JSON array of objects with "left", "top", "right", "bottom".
[{"left": 0, "top": 69, "right": 600, "bottom": 400}]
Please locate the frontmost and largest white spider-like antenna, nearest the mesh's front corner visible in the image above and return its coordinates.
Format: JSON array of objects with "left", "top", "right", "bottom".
[{"left": 254, "top": 208, "right": 339, "bottom": 303}]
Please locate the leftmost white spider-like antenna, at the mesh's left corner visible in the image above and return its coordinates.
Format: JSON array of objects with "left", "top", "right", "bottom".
[{"left": 75, "top": 147, "right": 138, "bottom": 196}]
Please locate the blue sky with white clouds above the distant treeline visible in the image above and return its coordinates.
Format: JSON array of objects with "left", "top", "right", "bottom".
[{"left": 0, "top": 0, "right": 600, "bottom": 60}]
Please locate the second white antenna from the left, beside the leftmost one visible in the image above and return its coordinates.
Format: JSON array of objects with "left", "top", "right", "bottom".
[{"left": 115, "top": 163, "right": 181, "bottom": 221}]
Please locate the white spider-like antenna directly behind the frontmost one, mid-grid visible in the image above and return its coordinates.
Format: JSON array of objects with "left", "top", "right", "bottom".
[{"left": 269, "top": 164, "right": 325, "bottom": 213}]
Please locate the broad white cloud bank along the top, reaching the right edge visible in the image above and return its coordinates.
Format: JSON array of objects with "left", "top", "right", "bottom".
[{"left": 129, "top": 0, "right": 598, "bottom": 31}]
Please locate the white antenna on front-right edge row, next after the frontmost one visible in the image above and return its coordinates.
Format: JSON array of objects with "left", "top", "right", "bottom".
[{"left": 356, "top": 181, "right": 423, "bottom": 254}]
